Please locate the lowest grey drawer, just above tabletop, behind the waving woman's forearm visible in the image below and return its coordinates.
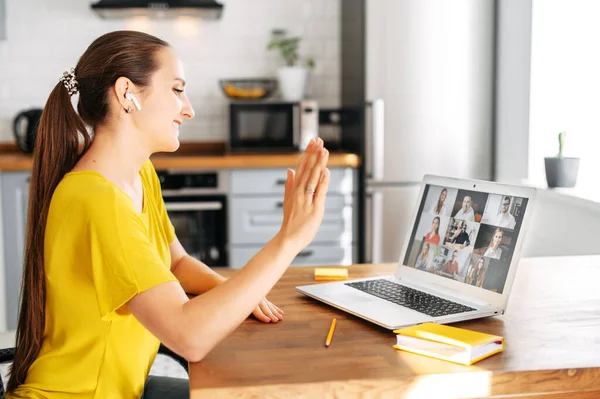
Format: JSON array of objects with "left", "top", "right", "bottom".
[{"left": 229, "top": 244, "right": 356, "bottom": 269}]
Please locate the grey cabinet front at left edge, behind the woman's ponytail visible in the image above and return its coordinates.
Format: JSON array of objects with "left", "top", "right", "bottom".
[{"left": 0, "top": 172, "right": 30, "bottom": 330}]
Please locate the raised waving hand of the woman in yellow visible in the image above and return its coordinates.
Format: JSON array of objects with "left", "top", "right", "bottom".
[{"left": 280, "top": 138, "right": 330, "bottom": 251}]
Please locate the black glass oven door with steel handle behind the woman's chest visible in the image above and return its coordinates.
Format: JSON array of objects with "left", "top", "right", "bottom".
[{"left": 163, "top": 195, "right": 228, "bottom": 266}]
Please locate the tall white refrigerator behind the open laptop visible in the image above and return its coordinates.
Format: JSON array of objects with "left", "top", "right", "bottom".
[{"left": 363, "top": 0, "right": 495, "bottom": 263}]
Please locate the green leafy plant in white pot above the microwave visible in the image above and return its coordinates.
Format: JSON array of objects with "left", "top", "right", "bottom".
[{"left": 267, "top": 29, "right": 314, "bottom": 101}]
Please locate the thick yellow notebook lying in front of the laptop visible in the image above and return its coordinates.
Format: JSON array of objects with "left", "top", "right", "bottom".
[{"left": 394, "top": 323, "right": 504, "bottom": 365}]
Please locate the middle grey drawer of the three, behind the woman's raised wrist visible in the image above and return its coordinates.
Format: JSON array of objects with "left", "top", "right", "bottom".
[{"left": 229, "top": 195, "right": 354, "bottom": 245}]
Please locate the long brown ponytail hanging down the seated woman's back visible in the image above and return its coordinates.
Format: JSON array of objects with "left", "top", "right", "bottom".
[{"left": 7, "top": 82, "right": 91, "bottom": 392}]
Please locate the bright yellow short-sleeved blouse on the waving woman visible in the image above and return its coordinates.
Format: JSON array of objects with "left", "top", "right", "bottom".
[{"left": 6, "top": 161, "right": 177, "bottom": 399}]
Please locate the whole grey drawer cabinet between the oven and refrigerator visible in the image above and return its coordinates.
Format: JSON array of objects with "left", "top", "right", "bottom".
[{"left": 228, "top": 167, "right": 358, "bottom": 269}]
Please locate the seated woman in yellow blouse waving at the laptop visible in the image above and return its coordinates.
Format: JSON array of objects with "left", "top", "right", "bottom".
[{"left": 6, "top": 31, "right": 330, "bottom": 399}]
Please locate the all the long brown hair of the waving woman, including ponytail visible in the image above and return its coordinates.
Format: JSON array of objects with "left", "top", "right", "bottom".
[{"left": 7, "top": 31, "right": 169, "bottom": 392}]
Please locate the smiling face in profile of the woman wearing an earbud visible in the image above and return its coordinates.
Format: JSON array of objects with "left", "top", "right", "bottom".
[{"left": 134, "top": 47, "right": 194, "bottom": 153}]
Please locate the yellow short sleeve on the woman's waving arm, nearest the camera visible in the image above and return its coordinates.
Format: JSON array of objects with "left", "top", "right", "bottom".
[{"left": 88, "top": 188, "right": 177, "bottom": 320}]
